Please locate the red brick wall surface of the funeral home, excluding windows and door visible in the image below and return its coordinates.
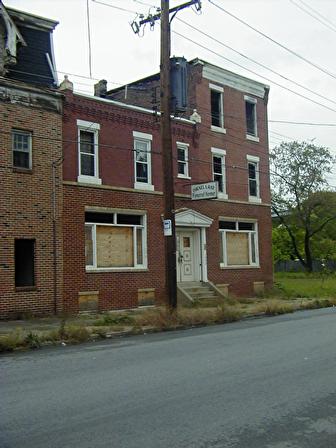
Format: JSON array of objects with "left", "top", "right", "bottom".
[{"left": 63, "top": 84, "right": 272, "bottom": 312}]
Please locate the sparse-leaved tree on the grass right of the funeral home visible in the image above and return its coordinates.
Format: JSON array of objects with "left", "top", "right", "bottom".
[{"left": 271, "top": 141, "right": 336, "bottom": 272}]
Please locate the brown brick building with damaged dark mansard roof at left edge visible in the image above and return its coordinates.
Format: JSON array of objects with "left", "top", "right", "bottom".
[{"left": 0, "top": 4, "right": 63, "bottom": 318}]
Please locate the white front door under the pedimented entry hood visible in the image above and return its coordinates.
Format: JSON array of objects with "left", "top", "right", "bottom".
[{"left": 176, "top": 230, "right": 200, "bottom": 282}]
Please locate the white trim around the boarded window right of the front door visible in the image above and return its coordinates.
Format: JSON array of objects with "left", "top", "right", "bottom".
[{"left": 219, "top": 219, "right": 260, "bottom": 269}]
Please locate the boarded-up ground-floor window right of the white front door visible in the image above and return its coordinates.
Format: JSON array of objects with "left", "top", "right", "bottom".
[{"left": 219, "top": 220, "right": 259, "bottom": 267}]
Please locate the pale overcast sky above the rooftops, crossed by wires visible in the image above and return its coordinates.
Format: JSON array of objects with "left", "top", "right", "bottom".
[{"left": 3, "top": 0, "right": 336, "bottom": 185}]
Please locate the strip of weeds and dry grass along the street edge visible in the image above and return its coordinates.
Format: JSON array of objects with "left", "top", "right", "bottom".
[{"left": 0, "top": 298, "right": 336, "bottom": 353}]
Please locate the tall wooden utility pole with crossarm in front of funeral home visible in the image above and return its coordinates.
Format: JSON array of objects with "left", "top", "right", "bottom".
[{"left": 131, "top": 0, "right": 201, "bottom": 311}]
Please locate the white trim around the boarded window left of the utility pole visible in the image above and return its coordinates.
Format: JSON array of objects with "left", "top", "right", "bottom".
[{"left": 85, "top": 213, "right": 148, "bottom": 272}]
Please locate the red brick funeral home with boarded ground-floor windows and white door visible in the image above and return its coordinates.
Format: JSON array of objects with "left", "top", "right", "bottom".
[{"left": 61, "top": 60, "right": 272, "bottom": 312}]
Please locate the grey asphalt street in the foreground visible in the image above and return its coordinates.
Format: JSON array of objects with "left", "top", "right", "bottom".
[{"left": 0, "top": 308, "right": 336, "bottom": 448}]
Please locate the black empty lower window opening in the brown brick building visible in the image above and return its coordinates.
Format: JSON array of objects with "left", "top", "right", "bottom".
[{"left": 14, "top": 239, "right": 35, "bottom": 287}]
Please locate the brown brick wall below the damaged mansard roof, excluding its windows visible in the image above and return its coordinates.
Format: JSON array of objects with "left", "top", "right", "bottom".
[{"left": 0, "top": 91, "right": 63, "bottom": 318}]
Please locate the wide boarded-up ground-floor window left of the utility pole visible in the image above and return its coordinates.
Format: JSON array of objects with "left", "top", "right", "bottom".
[{"left": 85, "top": 211, "right": 147, "bottom": 270}]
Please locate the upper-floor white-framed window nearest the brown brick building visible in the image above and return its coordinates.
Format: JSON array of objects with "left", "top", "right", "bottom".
[{"left": 77, "top": 120, "right": 101, "bottom": 184}]
